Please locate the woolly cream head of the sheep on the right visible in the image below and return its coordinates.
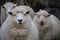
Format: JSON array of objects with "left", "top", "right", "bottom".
[{"left": 35, "top": 10, "right": 50, "bottom": 25}]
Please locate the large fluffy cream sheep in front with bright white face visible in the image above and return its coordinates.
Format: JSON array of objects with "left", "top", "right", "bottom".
[{"left": 1, "top": 6, "right": 38, "bottom": 40}]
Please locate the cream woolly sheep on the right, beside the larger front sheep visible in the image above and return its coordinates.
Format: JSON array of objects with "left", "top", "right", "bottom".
[{"left": 33, "top": 10, "right": 60, "bottom": 40}]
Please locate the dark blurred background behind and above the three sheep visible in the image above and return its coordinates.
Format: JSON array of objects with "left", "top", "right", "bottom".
[{"left": 0, "top": 0, "right": 60, "bottom": 40}]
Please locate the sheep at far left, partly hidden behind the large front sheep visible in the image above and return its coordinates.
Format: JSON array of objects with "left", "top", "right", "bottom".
[{"left": 1, "top": 2, "right": 17, "bottom": 24}]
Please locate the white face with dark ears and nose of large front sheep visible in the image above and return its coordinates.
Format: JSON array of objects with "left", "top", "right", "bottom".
[{"left": 9, "top": 9, "right": 30, "bottom": 24}]
